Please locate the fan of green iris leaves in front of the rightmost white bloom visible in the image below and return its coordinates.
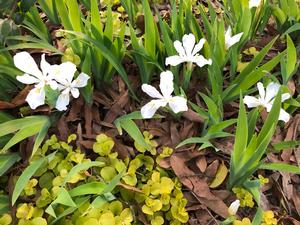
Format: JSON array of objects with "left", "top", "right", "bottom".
[{"left": 227, "top": 88, "right": 300, "bottom": 194}]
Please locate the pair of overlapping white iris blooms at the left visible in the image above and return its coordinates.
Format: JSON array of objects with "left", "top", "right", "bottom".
[{"left": 14, "top": 52, "right": 89, "bottom": 111}]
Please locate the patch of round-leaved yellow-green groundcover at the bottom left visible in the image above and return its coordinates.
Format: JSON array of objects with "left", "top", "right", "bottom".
[{"left": 0, "top": 133, "right": 188, "bottom": 225}]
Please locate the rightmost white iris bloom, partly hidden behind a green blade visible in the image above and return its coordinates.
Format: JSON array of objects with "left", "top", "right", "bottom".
[{"left": 244, "top": 82, "right": 291, "bottom": 122}]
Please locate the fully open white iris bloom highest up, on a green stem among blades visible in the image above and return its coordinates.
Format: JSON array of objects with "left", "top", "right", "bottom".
[{"left": 166, "top": 34, "right": 212, "bottom": 67}]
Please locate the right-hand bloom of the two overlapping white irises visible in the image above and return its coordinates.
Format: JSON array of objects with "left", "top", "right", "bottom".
[{"left": 51, "top": 62, "right": 90, "bottom": 111}]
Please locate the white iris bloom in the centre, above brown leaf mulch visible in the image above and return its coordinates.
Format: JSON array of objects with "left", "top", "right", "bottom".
[{"left": 141, "top": 71, "right": 188, "bottom": 119}]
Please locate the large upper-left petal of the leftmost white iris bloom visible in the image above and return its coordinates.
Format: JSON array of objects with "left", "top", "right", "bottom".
[{"left": 14, "top": 52, "right": 42, "bottom": 79}]
